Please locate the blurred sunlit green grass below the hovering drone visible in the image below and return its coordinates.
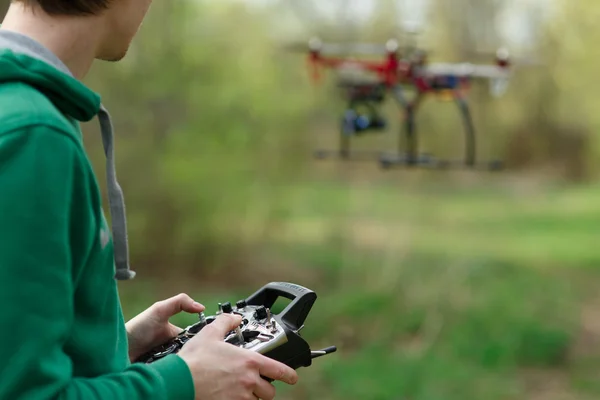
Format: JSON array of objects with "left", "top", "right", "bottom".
[{"left": 122, "top": 174, "right": 600, "bottom": 400}]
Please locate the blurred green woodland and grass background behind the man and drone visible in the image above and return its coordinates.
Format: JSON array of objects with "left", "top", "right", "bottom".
[{"left": 4, "top": 0, "right": 600, "bottom": 400}]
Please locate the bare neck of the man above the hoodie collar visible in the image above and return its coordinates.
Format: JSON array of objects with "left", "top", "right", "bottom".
[{"left": 0, "top": 2, "right": 104, "bottom": 80}]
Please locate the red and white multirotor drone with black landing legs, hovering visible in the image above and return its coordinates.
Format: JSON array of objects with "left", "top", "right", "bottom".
[{"left": 288, "top": 38, "right": 513, "bottom": 170}]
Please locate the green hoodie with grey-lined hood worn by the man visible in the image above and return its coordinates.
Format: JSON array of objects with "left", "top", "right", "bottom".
[{"left": 0, "top": 30, "right": 194, "bottom": 400}]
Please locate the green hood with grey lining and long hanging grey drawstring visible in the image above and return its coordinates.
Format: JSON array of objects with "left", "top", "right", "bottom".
[{"left": 0, "top": 30, "right": 135, "bottom": 280}]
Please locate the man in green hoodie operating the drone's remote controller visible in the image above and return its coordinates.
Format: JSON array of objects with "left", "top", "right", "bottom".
[{"left": 0, "top": 0, "right": 297, "bottom": 400}]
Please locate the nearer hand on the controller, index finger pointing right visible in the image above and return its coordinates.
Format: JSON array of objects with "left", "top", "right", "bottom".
[{"left": 179, "top": 314, "right": 298, "bottom": 400}]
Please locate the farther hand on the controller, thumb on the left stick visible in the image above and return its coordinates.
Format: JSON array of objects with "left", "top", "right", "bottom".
[{"left": 125, "top": 293, "right": 205, "bottom": 362}]
